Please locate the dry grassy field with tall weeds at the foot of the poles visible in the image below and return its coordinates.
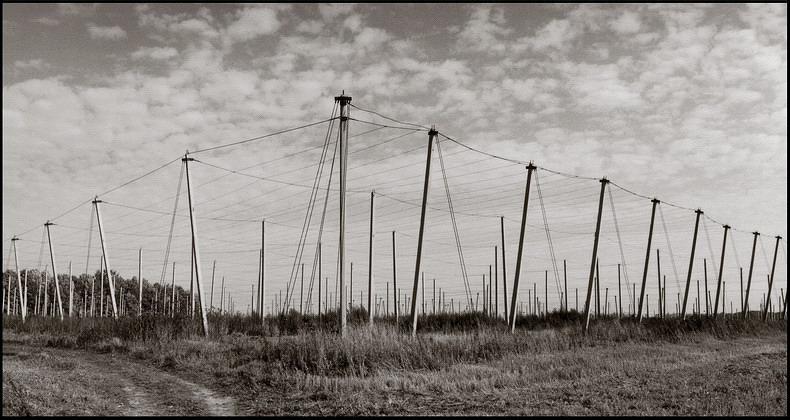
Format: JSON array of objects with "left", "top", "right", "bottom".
[{"left": 3, "top": 313, "right": 787, "bottom": 415}]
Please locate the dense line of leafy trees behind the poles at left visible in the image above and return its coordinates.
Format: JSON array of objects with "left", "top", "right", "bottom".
[{"left": 2, "top": 269, "right": 210, "bottom": 317}]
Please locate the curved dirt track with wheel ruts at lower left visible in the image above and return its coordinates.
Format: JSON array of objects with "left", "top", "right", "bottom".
[{"left": 3, "top": 342, "right": 236, "bottom": 416}]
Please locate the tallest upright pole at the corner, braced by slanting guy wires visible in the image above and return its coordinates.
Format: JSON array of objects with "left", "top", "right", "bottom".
[{"left": 335, "top": 94, "right": 351, "bottom": 337}]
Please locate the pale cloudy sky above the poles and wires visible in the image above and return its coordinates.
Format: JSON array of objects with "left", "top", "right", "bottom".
[{"left": 3, "top": 3, "right": 787, "bottom": 316}]
